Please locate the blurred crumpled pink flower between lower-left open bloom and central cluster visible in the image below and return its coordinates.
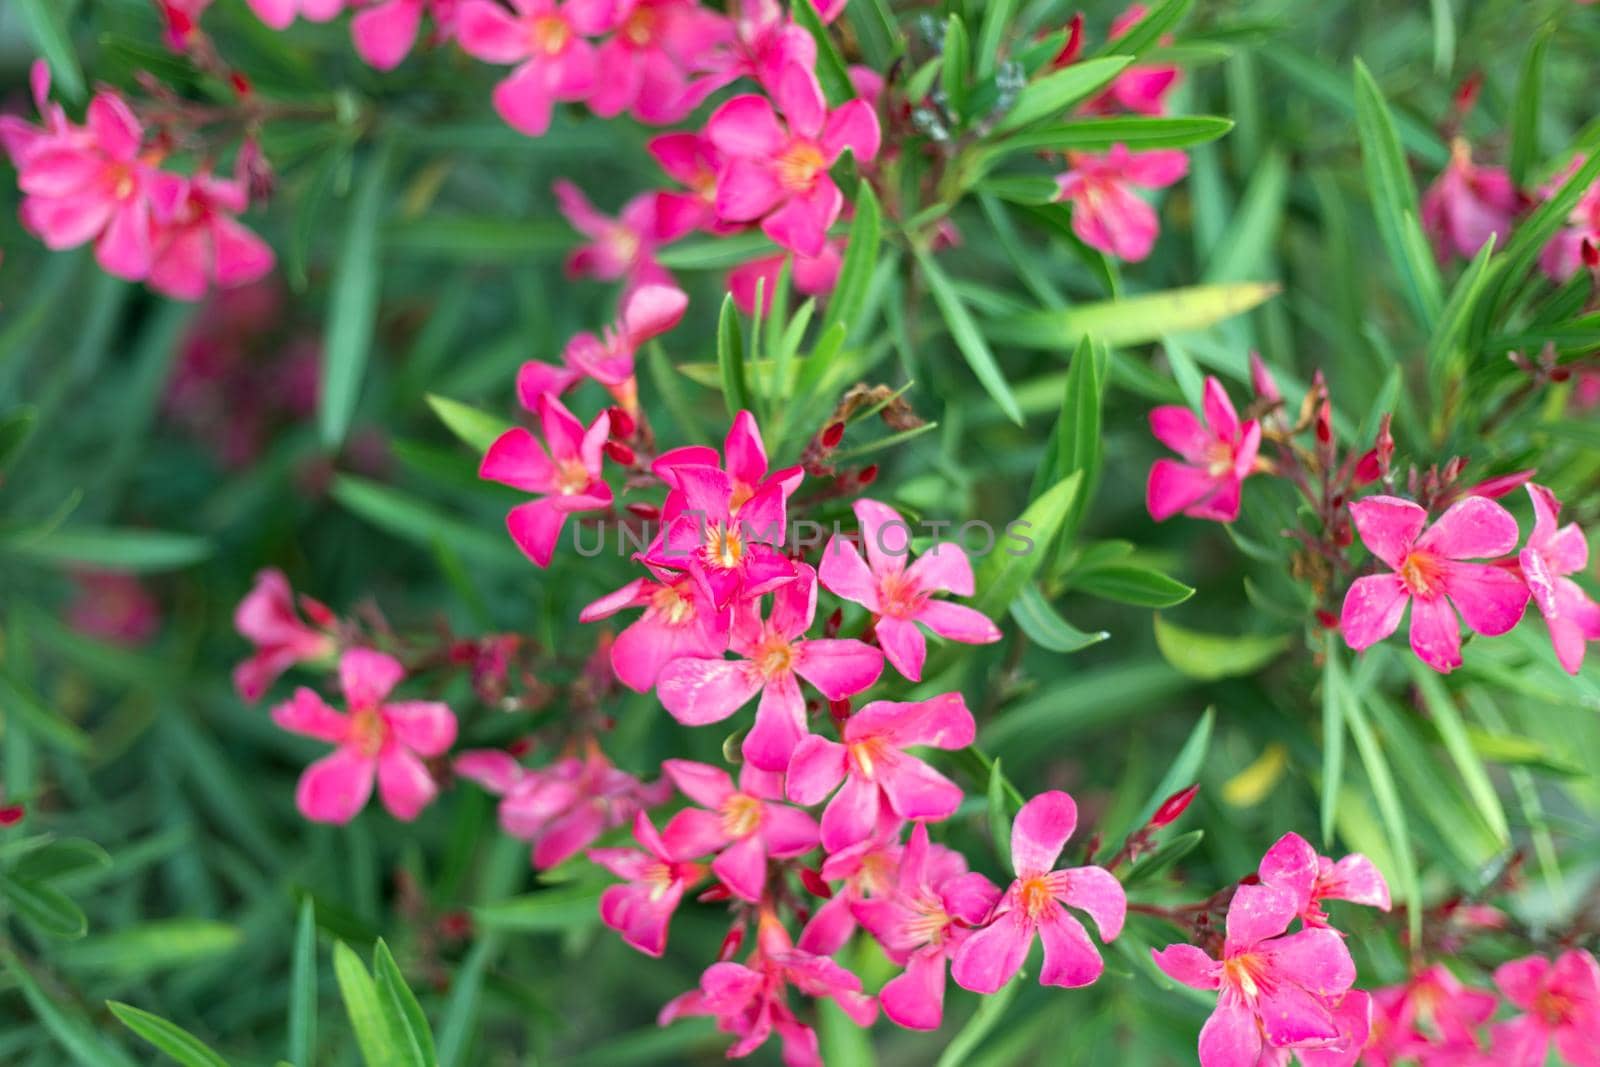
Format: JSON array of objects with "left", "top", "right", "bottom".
[{"left": 454, "top": 742, "right": 672, "bottom": 870}]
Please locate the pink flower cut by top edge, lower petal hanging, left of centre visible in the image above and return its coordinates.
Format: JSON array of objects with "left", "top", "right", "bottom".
[{"left": 456, "top": 0, "right": 614, "bottom": 138}]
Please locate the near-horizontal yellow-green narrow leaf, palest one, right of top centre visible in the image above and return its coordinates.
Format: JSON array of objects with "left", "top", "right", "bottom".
[{"left": 986, "top": 282, "right": 1278, "bottom": 352}]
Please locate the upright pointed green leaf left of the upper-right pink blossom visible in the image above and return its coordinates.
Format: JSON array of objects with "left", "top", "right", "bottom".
[{"left": 1355, "top": 59, "right": 1443, "bottom": 330}]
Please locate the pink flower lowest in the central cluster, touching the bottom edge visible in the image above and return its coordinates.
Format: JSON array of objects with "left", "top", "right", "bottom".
[{"left": 658, "top": 909, "right": 878, "bottom": 1067}]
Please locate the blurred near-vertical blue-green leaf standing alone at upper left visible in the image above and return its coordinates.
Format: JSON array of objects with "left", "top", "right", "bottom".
[{"left": 317, "top": 139, "right": 394, "bottom": 451}]
